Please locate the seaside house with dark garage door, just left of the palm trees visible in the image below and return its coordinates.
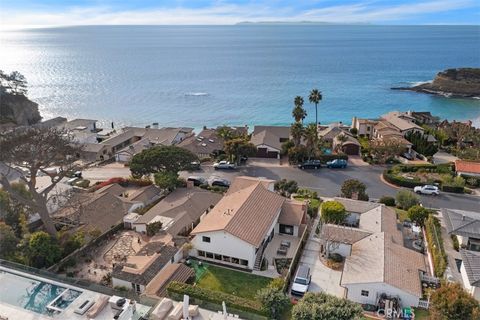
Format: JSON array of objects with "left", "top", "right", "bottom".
[{"left": 250, "top": 126, "right": 290, "bottom": 159}]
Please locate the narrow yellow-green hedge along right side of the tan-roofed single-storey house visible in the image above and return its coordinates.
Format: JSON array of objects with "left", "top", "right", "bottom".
[{"left": 425, "top": 215, "right": 447, "bottom": 278}]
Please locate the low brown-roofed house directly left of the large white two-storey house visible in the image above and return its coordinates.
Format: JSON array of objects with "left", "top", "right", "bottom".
[{"left": 129, "top": 188, "right": 222, "bottom": 236}]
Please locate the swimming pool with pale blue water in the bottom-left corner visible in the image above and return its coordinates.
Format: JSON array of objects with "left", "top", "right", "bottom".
[{"left": 0, "top": 269, "right": 82, "bottom": 315}]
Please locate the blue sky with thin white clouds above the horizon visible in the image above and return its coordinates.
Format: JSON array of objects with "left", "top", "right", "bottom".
[{"left": 0, "top": 0, "right": 480, "bottom": 29}]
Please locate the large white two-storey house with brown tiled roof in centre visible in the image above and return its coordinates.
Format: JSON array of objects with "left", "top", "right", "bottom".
[{"left": 191, "top": 177, "right": 306, "bottom": 270}]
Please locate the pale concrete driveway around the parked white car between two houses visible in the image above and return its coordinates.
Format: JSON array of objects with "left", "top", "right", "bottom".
[{"left": 292, "top": 218, "right": 345, "bottom": 298}]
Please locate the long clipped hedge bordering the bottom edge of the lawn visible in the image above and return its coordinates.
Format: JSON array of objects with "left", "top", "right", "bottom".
[{"left": 167, "top": 281, "right": 267, "bottom": 316}]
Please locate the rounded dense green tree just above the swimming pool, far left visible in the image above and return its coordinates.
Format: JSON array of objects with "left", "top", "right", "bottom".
[{"left": 27, "top": 231, "right": 62, "bottom": 268}]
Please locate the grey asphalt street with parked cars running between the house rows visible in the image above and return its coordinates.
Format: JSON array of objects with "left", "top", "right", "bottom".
[{"left": 83, "top": 165, "right": 480, "bottom": 212}]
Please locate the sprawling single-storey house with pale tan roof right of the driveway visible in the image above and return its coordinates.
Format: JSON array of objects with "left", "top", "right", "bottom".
[{"left": 320, "top": 198, "right": 427, "bottom": 307}]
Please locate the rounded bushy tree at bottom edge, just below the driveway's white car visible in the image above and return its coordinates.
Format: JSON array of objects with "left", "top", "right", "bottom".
[{"left": 292, "top": 292, "right": 363, "bottom": 320}]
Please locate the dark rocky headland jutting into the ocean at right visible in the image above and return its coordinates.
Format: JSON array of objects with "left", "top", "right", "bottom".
[{"left": 392, "top": 68, "right": 480, "bottom": 98}]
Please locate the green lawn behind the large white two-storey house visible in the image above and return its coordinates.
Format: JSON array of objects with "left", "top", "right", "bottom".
[{"left": 197, "top": 263, "right": 271, "bottom": 300}]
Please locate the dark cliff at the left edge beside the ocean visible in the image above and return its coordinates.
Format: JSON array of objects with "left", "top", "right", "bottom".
[{"left": 0, "top": 93, "right": 42, "bottom": 126}]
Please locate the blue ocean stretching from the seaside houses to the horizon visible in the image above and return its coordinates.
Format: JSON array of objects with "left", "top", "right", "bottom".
[{"left": 0, "top": 25, "right": 480, "bottom": 128}]
